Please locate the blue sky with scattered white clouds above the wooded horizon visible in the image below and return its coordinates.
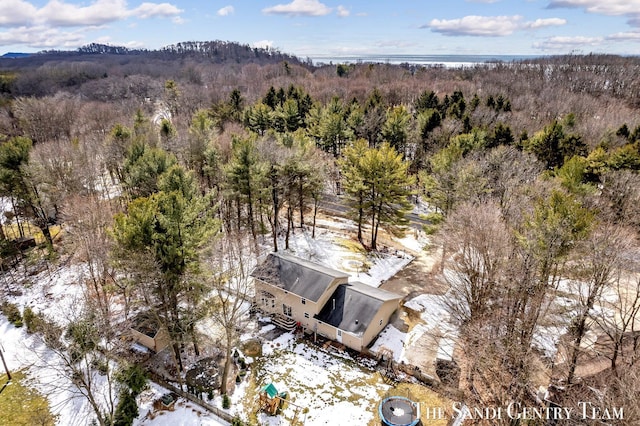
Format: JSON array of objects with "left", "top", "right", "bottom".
[{"left": 0, "top": 0, "right": 640, "bottom": 57}]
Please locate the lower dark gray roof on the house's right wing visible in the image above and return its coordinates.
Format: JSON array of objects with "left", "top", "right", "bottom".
[{"left": 316, "top": 282, "right": 402, "bottom": 335}]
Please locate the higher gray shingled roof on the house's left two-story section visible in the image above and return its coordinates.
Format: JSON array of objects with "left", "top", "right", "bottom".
[{"left": 251, "top": 253, "right": 349, "bottom": 302}]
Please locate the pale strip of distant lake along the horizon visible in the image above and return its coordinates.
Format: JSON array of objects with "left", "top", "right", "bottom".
[{"left": 308, "top": 55, "right": 543, "bottom": 68}]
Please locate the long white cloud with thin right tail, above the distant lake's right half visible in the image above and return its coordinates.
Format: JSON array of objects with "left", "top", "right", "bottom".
[{"left": 428, "top": 15, "right": 567, "bottom": 37}]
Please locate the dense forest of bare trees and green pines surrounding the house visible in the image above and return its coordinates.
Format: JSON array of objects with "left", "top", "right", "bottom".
[{"left": 0, "top": 42, "right": 640, "bottom": 424}]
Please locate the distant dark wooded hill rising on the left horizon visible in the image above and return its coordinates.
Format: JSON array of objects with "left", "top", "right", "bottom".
[{"left": 0, "top": 40, "right": 310, "bottom": 99}]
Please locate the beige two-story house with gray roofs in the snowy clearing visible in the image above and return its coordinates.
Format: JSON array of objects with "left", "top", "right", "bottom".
[{"left": 251, "top": 253, "right": 401, "bottom": 351}]
